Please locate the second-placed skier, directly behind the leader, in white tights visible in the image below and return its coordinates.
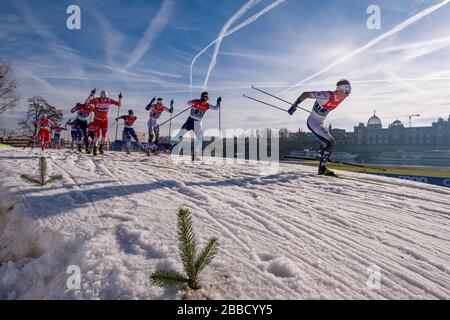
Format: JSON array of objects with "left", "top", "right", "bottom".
[{"left": 171, "top": 92, "right": 222, "bottom": 159}]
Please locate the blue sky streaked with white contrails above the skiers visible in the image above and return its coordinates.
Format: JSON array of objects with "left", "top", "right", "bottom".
[{"left": 0, "top": 0, "right": 450, "bottom": 133}]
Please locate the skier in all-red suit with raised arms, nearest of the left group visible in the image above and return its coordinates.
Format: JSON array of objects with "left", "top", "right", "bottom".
[{"left": 86, "top": 90, "right": 122, "bottom": 156}]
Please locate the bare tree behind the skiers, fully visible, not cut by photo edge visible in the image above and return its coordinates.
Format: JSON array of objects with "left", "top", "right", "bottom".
[{"left": 19, "top": 96, "right": 64, "bottom": 134}]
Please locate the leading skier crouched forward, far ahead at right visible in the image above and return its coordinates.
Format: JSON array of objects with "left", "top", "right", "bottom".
[{"left": 289, "top": 80, "right": 352, "bottom": 176}]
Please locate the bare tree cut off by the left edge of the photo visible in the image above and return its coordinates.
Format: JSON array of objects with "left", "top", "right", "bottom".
[{"left": 0, "top": 59, "right": 19, "bottom": 113}]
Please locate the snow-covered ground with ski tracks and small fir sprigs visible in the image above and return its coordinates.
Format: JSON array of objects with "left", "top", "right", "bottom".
[{"left": 0, "top": 148, "right": 450, "bottom": 299}]
